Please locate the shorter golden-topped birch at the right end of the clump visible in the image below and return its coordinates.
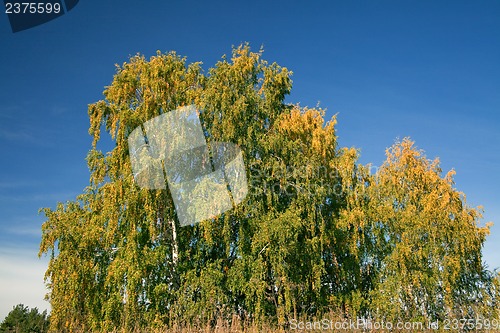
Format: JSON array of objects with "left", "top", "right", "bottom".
[{"left": 342, "top": 139, "right": 499, "bottom": 321}]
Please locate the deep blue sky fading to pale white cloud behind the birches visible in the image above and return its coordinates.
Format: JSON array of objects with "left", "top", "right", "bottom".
[{"left": 0, "top": 0, "right": 500, "bottom": 319}]
